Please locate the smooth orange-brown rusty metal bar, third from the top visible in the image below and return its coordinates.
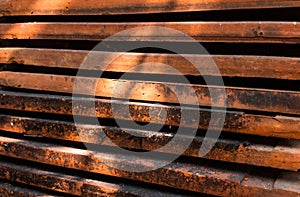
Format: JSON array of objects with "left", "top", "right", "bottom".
[{"left": 0, "top": 48, "right": 300, "bottom": 80}]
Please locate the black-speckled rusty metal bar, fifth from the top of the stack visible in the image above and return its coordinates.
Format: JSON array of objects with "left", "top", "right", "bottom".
[{"left": 0, "top": 91, "right": 300, "bottom": 139}]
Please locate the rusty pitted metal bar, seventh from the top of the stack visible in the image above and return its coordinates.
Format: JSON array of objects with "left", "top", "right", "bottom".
[{"left": 0, "top": 137, "right": 299, "bottom": 196}]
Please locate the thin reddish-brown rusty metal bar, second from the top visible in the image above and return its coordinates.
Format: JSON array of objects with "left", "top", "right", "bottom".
[{"left": 0, "top": 22, "right": 300, "bottom": 44}]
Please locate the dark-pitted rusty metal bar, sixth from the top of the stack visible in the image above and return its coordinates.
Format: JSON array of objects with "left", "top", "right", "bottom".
[{"left": 0, "top": 115, "right": 300, "bottom": 171}]
